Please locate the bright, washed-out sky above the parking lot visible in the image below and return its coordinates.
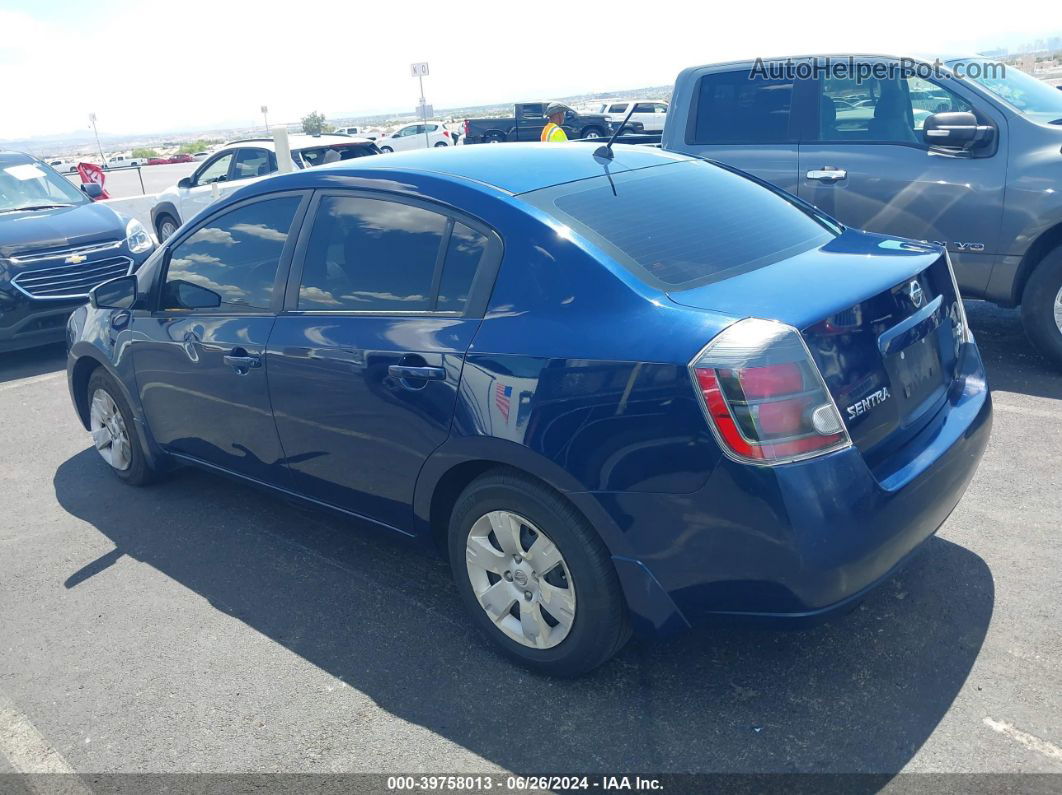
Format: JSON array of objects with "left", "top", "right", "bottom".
[{"left": 0, "top": 0, "right": 1062, "bottom": 139}]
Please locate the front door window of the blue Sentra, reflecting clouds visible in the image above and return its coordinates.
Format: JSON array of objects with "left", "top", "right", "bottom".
[{"left": 159, "top": 196, "right": 302, "bottom": 313}]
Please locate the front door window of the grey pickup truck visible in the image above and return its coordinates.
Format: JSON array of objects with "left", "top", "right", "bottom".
[{"left": 819, "top": 69, "right": 973, "bottom": 144}]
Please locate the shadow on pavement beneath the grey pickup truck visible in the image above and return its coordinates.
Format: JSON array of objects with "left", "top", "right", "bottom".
[{"left": 965, "top": 300, "right": 1062, "bottom": 400}]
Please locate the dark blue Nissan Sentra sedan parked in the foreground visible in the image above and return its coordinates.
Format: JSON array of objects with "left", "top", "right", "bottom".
[{"left": 68, "top": 143, "right": 991, "bottom": 675}]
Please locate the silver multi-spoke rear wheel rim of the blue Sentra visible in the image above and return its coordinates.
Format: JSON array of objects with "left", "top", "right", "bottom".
[{"left": 465, "top": 511, "right": 576, "bottom": 649}]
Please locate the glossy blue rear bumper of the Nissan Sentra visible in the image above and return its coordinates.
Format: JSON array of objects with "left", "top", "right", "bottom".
[{"left": 595, "top": 344, "right": 992, "bottom": 634}]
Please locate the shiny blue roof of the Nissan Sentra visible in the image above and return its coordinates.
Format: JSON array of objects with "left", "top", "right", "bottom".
[{"left": 259, "top": 141, "right": 696, "bottom": 195}]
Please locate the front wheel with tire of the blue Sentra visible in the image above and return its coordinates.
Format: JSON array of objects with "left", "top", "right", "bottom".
[{"left": 85, "top": 368, "right": 156, "bottom": 486}]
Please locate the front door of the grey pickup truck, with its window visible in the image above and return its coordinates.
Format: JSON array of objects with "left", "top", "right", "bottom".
[{"left": 799, "top": 62, "right": 1006, "bottom": 293}]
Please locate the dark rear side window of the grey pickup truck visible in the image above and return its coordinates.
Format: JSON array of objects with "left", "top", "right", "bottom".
[{"left": 691, "top": 69, "right": 793, "bottom": 144}]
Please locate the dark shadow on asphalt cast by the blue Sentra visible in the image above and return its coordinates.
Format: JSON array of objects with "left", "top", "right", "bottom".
[{"left": 54, "top": 448, "right": 995, "bottom": 776}]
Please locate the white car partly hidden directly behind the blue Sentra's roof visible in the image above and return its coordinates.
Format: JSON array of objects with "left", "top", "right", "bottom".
[{"left": 151, "top": 135, "right": 380, "bottom": 242}]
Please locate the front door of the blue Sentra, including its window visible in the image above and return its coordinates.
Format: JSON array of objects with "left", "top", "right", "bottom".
[{"left": 132, "top": 191, "right": 309, "bottom": 484}]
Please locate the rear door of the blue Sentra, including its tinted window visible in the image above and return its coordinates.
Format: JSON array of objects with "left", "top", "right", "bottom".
[{"left": 267, "top": 191, "right": 501, "bottom": 528}]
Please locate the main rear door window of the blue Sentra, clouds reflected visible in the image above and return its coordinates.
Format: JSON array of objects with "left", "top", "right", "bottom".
[{"left": 297, "top": 196, "right": 449, "bottom": 312}]
